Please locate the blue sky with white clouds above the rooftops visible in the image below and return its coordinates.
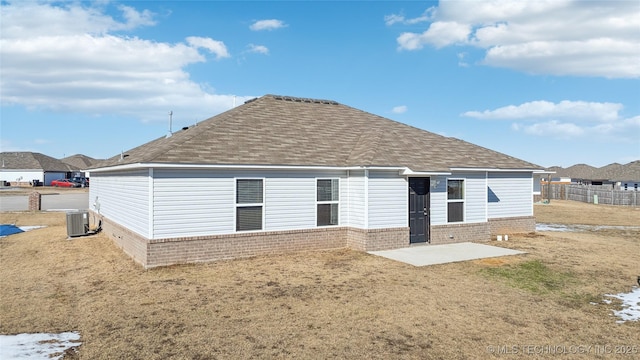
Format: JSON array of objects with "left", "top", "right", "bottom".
[{"left": 0, "top": 0, "right": 640, "bottom": 167}]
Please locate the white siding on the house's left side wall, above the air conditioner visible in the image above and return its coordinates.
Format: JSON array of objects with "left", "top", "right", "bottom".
[{"left": 89, "top": 169, "right": 149, "bottom": 237}]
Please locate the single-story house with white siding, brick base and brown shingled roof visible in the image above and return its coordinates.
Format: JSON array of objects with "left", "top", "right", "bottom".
[{"left": 89, "top": 95, "right": 543, "bottom": 268}]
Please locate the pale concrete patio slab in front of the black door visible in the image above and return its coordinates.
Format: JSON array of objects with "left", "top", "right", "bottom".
[{"left": 369, "top": 242, "right": 525, "bottom": 266}]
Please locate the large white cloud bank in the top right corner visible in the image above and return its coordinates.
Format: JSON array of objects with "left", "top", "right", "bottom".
[{"left": 385, "top": 0, "right": 640, "bottom": 78}]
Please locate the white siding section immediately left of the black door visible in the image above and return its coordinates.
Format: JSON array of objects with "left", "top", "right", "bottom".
[{"left": 368, "top": 170, "right": 409, "bottom": 229}]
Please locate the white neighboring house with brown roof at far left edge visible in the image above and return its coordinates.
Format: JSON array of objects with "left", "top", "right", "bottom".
[{"left": 0, "top": 152, "right": 75, "bottom": 186}]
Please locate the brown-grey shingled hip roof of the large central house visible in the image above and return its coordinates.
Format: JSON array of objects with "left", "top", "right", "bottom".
[{"left": 95, "top": 95, "right": 542, "bottom": 171}]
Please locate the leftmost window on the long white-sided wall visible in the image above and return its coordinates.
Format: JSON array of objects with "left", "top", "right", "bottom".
[{"left": 236, "top": 179, "right": 264, "bottom": 231}]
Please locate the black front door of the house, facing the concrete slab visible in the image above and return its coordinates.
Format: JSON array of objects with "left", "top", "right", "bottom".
[{"left": 409, "top": 178, "right": 430, "bottom": 244}]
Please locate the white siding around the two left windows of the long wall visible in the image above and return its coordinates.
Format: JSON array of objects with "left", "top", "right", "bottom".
[{"left": 153, "top": 169, "right": 346, "bottom": 238}]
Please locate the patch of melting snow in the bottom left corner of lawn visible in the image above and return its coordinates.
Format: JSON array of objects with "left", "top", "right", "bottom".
[{"left": 0, "top": 331, "right": 80, "bottom": 360}]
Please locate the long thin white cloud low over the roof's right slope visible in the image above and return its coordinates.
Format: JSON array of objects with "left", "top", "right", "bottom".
[{"left": 462, "top": 100, "right": 623, "bottom": 122}]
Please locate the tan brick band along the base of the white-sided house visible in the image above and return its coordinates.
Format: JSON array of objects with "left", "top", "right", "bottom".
[{"left": 92, "top": 212, "right": 535, "bottom": 269}]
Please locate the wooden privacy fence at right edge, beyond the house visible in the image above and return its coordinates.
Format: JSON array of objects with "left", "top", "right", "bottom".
[{"left": 541, "top": 184, "right": 640, "bottom": 206}]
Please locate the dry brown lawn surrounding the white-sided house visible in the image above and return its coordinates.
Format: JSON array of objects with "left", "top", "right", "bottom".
[{"left": 0, "top": 201, "right": 640, "bottom": 359}]
